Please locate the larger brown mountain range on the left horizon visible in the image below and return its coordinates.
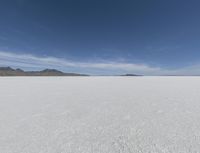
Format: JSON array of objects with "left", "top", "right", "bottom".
[{"left": 0, "top": 67, "right": 88, "bottom": 76}]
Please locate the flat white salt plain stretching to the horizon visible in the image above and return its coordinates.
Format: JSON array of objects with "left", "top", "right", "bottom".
[{"left": 0, "top": 77, "right": 200, "bottom": 153}]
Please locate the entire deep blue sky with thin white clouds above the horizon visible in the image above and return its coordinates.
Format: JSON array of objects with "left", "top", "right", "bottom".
[{"left": 0, "top": 0, "right": 200, "bottom": 75}]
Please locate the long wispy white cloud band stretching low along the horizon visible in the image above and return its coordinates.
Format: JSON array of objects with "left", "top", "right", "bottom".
[{"left": 0, "top": 51, "right": 200, "bottom": 75}]
